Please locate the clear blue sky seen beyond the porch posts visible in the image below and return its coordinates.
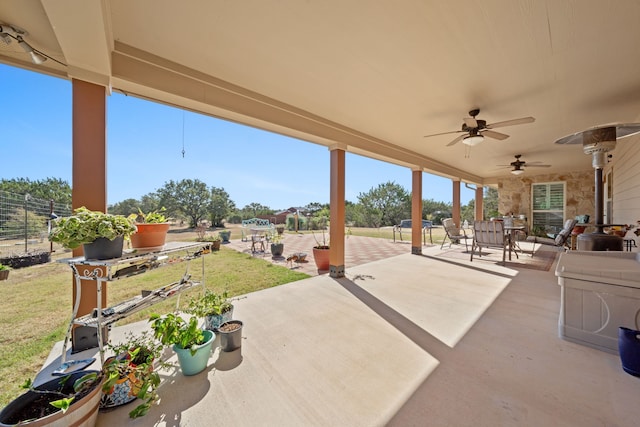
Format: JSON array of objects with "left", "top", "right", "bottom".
[{"left": 0, "top": 64, "right": 474, "bottom": 210}]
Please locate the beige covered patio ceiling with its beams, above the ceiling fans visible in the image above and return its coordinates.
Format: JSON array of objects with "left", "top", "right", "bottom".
[{"left": 0, "top": 0, "right": 640, "bottom": 184}]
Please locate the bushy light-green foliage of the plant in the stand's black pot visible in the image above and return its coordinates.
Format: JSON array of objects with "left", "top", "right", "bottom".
[{"left": 49, "top": 206, "right": 137, "bottom": 249}]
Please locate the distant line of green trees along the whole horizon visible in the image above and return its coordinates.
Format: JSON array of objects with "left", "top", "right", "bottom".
[{"left": 0, "top": 178, "right": 498, "bottom": 228}]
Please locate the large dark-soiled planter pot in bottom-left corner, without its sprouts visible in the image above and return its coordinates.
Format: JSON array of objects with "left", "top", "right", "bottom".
[{"left": 0, "top": 371, "right": 102, "bottom": 427}]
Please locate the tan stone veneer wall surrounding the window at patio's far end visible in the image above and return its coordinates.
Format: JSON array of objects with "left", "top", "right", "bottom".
[{"left": 498, "top": 169, "right": 595, "bottom": 219}]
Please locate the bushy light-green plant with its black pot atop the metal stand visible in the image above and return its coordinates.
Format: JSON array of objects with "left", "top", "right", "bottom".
[{"left": 49, "top": 206, "right": 137, "bottom": 259}]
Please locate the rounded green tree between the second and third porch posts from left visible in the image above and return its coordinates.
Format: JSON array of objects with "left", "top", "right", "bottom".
[{"left": 358, "top": 182, "right": 411, "bottom": 228}]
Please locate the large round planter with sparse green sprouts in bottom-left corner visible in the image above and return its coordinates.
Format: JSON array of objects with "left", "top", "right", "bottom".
[{"left": 0, "top": 371, "right": 104, "bottom": 427}]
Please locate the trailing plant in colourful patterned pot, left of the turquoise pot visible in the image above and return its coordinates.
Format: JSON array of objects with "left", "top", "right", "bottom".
[{"left": 100, "top": 331, "right": 167, "bottom": 418}]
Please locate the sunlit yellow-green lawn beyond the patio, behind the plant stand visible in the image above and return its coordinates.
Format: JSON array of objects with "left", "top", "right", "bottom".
[{"left": 0, "top": 246, "right": 309, "bottom": 407}]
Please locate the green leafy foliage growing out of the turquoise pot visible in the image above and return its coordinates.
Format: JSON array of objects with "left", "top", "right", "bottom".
[{"left": 149, "top": 313, "right": 204, "bottom": 355}]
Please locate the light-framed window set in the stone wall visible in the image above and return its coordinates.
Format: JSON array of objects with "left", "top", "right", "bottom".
[{"left": 531, "top": 182, "right": 565, "bottom": 233}]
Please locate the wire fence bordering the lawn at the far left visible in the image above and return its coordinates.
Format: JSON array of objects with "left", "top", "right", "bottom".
[{"left": 0, "top": 191, "right": 71, "bottom": 258}]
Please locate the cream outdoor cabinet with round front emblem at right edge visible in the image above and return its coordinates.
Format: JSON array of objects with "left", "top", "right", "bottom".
[{"left": 556, "top": 251, "right": 640, "bottom": 353}]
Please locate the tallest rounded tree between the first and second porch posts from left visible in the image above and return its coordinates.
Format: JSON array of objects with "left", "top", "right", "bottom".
[{"left": 157, "top": 179, "right": 211, "bottom": 228}]
